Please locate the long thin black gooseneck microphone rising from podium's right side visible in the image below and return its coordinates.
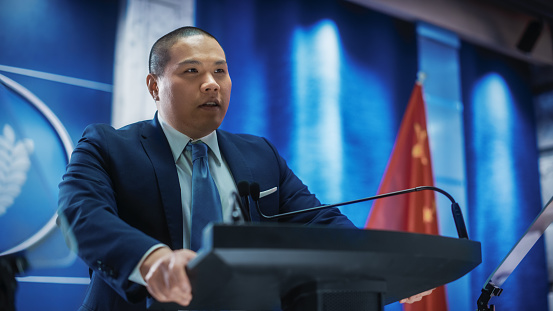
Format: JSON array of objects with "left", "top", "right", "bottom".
[{"left": 249, "top": 182, "right": 468, "bottom": 239}]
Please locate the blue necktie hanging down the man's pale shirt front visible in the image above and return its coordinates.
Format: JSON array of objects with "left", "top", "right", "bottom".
[{"left": 186, "top": 141, "right": 223, "bottom": 251}]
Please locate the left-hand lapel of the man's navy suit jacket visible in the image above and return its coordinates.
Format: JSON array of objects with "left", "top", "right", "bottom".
[{"left": 140, "top": 117, "right": 183, "bottom": 249}]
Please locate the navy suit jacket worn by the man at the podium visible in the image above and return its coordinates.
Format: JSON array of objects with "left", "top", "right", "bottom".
[{"left": 58, "top": 117, "right": 354, "bottom": 310}]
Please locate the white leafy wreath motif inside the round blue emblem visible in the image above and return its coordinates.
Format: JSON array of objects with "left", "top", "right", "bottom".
[{"left": 0, "top": 124, "right": 34, "bottom": 216}]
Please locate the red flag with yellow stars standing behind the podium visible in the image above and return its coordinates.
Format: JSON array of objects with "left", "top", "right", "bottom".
[{"left": 365, "top": 83, "right": 447, "bottom": 311}]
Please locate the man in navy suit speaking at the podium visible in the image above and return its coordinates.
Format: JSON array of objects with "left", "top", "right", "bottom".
[{"left": 59, "top": 27, "right": 426, "bottom": 310}]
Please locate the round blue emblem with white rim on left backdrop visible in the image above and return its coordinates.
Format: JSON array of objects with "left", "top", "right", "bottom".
[{"left": 0, "top": 75, "right": 73, "bottom": 256}]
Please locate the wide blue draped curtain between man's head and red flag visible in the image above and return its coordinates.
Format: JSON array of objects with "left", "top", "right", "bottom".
[{"left": 196, "top": 0, "right": 417, "bottom": 227}]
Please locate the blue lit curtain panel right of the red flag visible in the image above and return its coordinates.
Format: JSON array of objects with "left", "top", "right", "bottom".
[{"left": 461, "top": 43, "right": 548, "bottom": 310}]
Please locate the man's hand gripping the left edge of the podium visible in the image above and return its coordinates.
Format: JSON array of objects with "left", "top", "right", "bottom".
[{"left": 140, "top": 247, "right": 196, "bottom": 306}]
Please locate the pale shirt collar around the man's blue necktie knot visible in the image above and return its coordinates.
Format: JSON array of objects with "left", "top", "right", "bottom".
[{"left": 157, "top": 113, "right": 222, "bottom": 163}]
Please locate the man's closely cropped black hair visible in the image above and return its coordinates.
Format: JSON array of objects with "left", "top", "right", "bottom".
[{"left": 148, "top": 26, "right": 219, "bottom": 75}]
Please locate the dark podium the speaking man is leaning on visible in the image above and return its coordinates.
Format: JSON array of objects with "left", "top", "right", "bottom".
[{"left": 148, "top": 224, "right": 482, "bottom": 311}]
